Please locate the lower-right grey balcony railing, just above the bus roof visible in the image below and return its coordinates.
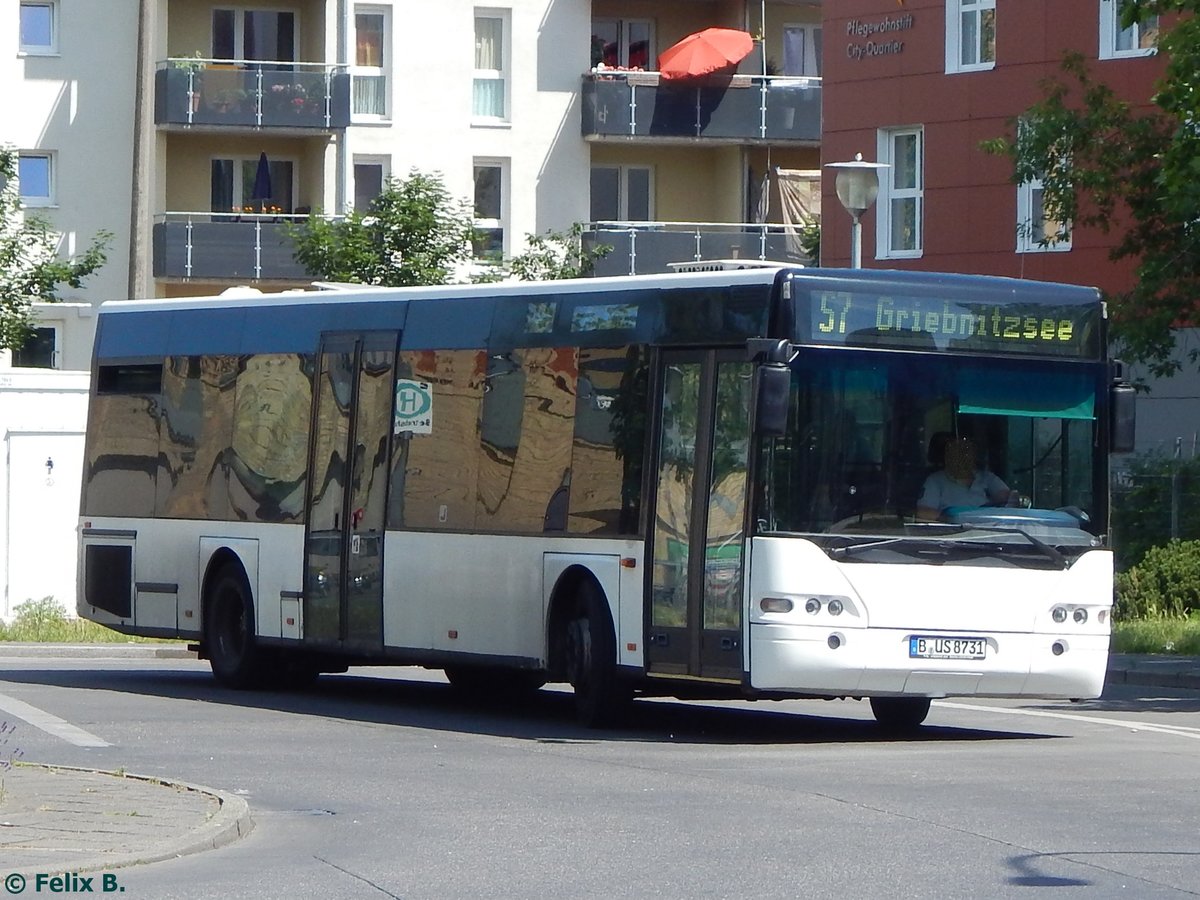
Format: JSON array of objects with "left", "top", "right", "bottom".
[{"left": 583, "top": 222, "right": 811, "bottom": 275}]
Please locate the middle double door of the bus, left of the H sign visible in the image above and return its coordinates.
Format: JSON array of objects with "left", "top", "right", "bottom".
[{"left": 304, "top": 331, "right": 400, "bottom": 650}]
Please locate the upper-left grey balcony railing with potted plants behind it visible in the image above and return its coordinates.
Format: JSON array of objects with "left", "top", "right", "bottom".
[{"left": 155, "top": 56, "right": 350, "bottom": 131}]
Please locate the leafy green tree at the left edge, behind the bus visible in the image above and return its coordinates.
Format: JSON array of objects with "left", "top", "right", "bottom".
[{"left": 0, "top": 148, "right": 112, "bottom": 350}]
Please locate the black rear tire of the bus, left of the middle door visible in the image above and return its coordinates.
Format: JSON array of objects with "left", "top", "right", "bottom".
[{"left": 204, "top": 565, "right": 263, "bottom": 690}]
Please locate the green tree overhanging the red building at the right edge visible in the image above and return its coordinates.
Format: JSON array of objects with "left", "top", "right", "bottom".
[{"left": 983, "top": 0, "right": 1200, "bottom": 376}]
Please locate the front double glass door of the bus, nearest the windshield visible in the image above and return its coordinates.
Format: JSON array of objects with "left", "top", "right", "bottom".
[{"left": 646, "top": 350, "right": 754, "bottom": 682}]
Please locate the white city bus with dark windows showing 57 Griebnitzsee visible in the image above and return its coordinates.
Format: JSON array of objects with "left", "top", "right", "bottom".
[{"left": 78, "top": 268, "right": 1133, "bottom": 726}]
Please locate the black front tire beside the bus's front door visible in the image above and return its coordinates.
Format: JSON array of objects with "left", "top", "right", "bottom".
[{"left": 565, "top": 581, "right": 632, "bottom": 728}]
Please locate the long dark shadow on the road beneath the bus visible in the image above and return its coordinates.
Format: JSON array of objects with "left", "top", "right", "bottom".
[{"left": 0, "top": 664, "right": 1056, "bottom": 745}]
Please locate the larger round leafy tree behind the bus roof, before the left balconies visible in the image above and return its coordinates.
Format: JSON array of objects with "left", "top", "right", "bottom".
[{"left": 289, "top": 169, "right": 474, "bottom": 287}]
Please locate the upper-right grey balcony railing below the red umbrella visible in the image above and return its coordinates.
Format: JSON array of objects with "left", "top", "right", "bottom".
[{"left": 582, "top": 72, "right": 821, "bottom": 142}]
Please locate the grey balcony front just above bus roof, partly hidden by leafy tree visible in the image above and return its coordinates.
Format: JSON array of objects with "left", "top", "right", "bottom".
[{"left": 154, "top": 212, "right": 324, "bottom": 282}]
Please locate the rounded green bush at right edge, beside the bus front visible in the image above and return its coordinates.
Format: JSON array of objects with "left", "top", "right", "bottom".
[{"left": 1114, "top": 541, "right": 1200, "bottom": 620}]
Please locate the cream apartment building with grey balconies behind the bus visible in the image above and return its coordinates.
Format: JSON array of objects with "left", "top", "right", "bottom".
[{"left": 0, "top": 0, "right": 821, "bottom": 368}]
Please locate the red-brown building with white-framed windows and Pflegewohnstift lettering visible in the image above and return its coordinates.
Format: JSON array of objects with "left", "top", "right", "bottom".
[{"left": 821, "top": 0, "right": 1200, "bottom": 455}]
